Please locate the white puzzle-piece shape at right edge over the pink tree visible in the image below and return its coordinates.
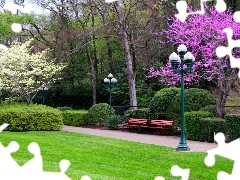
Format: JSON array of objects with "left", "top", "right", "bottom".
[{"left": 216, "top": 28, "right": 240, "bottom": 78}]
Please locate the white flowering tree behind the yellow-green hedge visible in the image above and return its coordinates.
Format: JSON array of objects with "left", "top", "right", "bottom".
[{"left": 0, "top": 40, "right": 65, "bottom": 104}]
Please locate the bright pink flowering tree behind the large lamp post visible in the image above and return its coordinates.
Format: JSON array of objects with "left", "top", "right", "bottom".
[{"left": 149, "top": 5, "right": 240, "bottom": 117}]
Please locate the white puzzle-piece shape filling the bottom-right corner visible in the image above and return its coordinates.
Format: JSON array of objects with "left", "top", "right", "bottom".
[{"left": 204, "top": 133, "right": 240, "bottom": 180}]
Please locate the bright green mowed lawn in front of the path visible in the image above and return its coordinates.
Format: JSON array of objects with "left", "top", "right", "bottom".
[{"left": 0, "top": 132, "right": 233, "bottom": 180}]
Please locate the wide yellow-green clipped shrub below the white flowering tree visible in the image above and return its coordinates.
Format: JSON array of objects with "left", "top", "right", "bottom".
[{"left": 0, "top": 104, "right": 63, "bottom": 131}]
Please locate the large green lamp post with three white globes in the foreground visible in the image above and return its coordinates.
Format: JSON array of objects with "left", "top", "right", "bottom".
[{"left": 169, "top": 44, "right": 195, "bottom": 151}]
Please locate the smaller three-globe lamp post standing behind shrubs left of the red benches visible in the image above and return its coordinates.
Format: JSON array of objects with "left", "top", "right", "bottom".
[{"left": 104, "top": 73, "right": 117, "bottom": 118}]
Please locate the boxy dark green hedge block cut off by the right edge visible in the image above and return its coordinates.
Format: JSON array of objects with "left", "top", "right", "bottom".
[{"left": 225, "top": 114, "right": 240, "bottom": 141}]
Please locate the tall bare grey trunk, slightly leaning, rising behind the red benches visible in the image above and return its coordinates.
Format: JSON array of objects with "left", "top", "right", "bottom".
[{"left": 114, "top": 2, "right": 137, "bottom": 106}]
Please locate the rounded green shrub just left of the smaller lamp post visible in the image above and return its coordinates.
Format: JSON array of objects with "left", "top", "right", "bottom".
[{"left": 86, "top": 103, "right": 115, "bottom": 126}]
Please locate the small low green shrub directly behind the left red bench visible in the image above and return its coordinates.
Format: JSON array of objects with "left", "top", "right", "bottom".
[{"left": 124, "top": 108, "right": 148, "bottom": 122}]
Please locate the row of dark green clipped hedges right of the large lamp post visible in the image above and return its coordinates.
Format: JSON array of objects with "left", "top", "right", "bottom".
[{"left": 185, "top": 111, "right": 240, "bottom": 142}]
